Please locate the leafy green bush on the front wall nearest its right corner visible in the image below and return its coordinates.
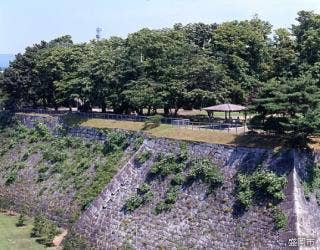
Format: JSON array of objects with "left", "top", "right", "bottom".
[{"left": 236, "top": 171, "right": 287, "bottom": 208}]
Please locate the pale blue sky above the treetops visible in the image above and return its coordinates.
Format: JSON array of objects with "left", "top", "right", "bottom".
[{"left": 0, "top": 0, "right": 320, "bottom": 54}]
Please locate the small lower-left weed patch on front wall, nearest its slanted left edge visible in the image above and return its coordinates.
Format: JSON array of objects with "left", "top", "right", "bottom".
[{"left": 123, "top": 183, "right": 153, "bottom": 212}]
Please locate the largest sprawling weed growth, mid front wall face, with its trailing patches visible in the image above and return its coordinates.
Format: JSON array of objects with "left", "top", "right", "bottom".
[{"left": 128, "top": 142, "right": 223, "bottom": 214}]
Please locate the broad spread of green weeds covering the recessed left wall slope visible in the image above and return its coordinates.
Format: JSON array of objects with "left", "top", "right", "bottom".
[{"left": 0, "top": 123, "right": 134, "bottom": 209}]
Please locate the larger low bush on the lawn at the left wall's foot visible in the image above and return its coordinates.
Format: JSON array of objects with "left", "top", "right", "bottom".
[{"left": 31, "top": 215, "right": 60, "bottom": 246}]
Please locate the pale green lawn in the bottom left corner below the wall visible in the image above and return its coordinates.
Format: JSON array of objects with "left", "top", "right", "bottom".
[{"left": 0, "top": 213, "right": 59, "bottom": 250}]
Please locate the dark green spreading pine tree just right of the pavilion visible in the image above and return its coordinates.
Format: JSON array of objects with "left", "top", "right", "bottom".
[{"left": 253, "top": 75, "right": 320, "bottom": 138}]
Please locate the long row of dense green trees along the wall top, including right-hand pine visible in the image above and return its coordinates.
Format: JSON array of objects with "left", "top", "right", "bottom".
[{"left": 0, "top": 11, "right": 320, "bottom": 137}]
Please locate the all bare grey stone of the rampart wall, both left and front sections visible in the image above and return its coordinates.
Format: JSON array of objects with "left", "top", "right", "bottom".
[{"left": 4, "top": 115, "right": 320, "bottom": 249}]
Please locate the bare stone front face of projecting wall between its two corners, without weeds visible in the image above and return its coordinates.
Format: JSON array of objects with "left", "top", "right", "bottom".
[{"left": 75, "top": 139, "right": 295, "bottom": 249}]
